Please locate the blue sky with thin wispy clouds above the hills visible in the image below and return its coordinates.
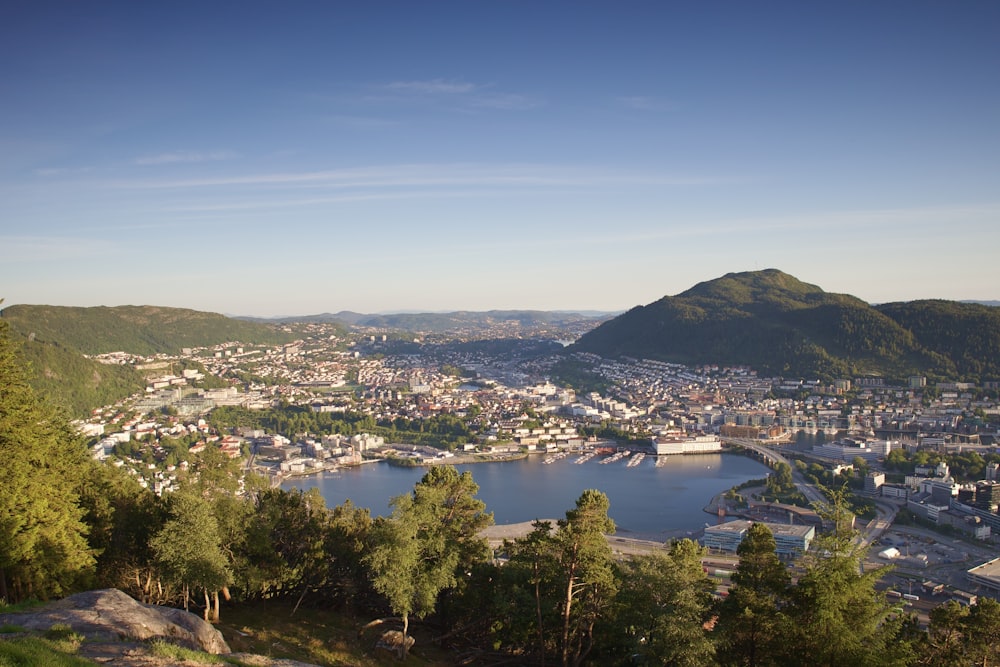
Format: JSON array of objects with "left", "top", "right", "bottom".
[{"left": 0, "top": 0, "right": 1000, "bottom": 317}]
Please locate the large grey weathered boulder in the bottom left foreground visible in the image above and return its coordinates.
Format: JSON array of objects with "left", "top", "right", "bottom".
[{"left": 0, "top": 588, "right": 230, "bottom": 653}]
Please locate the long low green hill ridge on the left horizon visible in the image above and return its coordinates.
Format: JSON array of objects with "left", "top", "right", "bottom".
[{"left": 0, "top": 305, "right": 292, "bottom": 354}]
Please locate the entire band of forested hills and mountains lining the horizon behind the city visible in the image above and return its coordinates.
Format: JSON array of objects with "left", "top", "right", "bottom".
[{"left": 0, "top": 280, "right": 1000, "bottom": 414}]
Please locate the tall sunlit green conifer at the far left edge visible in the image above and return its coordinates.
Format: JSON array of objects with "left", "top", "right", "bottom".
[{"left": 0, "top": 320, "right": 94, "bottom": 601}]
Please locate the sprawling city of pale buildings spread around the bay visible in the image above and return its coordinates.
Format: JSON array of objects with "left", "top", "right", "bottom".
[{"left": 79, "top": 324, "right": 1000, "bottom": 619}]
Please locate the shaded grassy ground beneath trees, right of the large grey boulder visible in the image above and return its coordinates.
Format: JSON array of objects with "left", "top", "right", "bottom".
[{"left": 216, "top": 602, "right": 454, "bottom": 667}]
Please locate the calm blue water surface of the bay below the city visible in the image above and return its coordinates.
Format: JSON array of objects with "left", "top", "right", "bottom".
[{"left": 283, "top": 453, "right": 769, "bottom": 538}]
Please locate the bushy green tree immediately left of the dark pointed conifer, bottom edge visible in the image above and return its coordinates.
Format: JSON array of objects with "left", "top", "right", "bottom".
[{"left": 615, "top": 540, "right": 715, "bottom": 667}]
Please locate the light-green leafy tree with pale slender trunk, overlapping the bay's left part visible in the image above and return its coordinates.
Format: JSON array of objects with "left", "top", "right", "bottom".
[{"left": 365, "top": 466, "right": 493, "bottom": 654}]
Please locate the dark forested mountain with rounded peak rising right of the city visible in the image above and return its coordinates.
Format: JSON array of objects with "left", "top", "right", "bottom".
[{"left": 570, "top": 269, "right": 1000, "bottom": 381}]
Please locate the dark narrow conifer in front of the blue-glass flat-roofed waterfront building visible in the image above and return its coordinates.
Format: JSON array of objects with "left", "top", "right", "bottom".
[{"left": 716, "top": 523, "right": 791, "bottom": 667}]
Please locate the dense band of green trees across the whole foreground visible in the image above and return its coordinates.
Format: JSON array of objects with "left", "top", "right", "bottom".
[{"left": 0, "top": 321, "right": 1000, "bottom": 666}]
